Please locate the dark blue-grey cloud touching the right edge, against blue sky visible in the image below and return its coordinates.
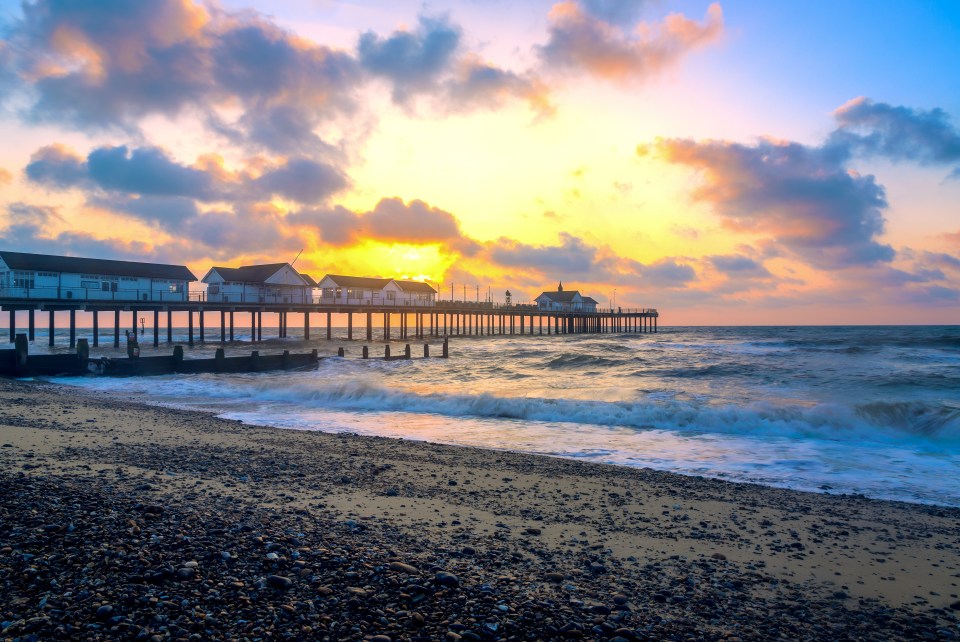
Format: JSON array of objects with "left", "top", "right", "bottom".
[{"left": 827, "top": 97, "right": 960, "bottom": 174}]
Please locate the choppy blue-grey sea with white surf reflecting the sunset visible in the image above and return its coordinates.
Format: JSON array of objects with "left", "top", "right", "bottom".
[{"left": 31, "top": 326, "right": 960, "bottom": 506}]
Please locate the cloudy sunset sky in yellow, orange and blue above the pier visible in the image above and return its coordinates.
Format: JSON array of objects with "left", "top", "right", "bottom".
[{"left": 0, "top": 0, "right": 960, "bottom": 325}]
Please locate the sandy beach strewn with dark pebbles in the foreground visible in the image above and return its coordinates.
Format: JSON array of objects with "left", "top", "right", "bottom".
[{"left": 0, "top": 380, "right": 960, "bottom": 642}]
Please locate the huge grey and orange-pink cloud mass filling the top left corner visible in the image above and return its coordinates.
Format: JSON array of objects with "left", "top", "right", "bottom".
[{"left": 0, "top": 0, "right": 362, "bottom": 153}]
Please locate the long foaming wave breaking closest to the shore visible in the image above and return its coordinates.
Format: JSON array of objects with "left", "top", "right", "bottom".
[{"left": 188, "top": 377, "right": 960, "bottom": 445}]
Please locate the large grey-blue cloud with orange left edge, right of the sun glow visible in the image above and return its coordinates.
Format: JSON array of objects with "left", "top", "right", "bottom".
[{"left": 638, "top": 139, "right": 894, "bottom": 269}]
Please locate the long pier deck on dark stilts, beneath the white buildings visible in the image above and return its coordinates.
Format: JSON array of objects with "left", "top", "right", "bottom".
[{"left": 0, "top": 299, "right": 659, "bottom": 348}]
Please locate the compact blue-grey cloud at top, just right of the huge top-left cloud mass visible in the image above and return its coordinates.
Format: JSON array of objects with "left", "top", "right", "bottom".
[{"left": 357, "top": 15, "right": 460, "bottom": 104}]
